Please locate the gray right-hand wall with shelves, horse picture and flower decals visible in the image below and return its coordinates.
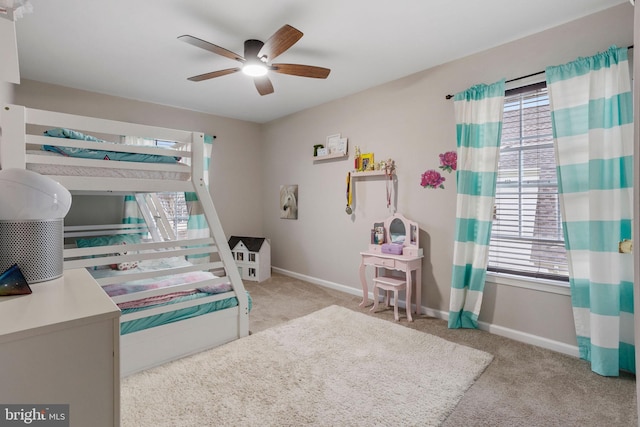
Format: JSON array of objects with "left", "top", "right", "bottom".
[{"left": 262, "top": 3, "right": 633, "bottom": 352}]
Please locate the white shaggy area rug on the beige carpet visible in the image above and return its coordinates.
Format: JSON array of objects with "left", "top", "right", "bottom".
[{"left": 121, "top": 306, "right": 493, "bottom": 427}]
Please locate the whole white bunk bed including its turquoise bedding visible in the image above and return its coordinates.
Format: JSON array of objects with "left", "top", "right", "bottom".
[{"left": 0, "top": 105, "right": 251, "bottom": 376}]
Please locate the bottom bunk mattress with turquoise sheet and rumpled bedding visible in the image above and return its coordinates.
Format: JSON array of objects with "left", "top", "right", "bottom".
[{"left": 90, "top": 257, "right": 252, "bottom": 335}]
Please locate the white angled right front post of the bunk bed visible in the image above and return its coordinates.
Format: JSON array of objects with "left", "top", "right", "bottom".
[{"left": 191, "top": 132, "right": 249, "bottom": 337}]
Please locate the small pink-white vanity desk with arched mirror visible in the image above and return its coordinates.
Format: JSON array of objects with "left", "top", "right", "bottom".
[{"left": 360, "top": 214, "right": 423, "bottom": 321}]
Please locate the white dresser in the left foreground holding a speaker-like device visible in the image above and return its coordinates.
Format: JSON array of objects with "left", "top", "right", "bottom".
[{"left": 0, "top": 269, "right": 120, "bottom": 426}]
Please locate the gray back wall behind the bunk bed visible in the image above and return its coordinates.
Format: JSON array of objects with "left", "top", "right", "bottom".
[{"left": 15, "top": 79, "right": 263, "bottom": 241}]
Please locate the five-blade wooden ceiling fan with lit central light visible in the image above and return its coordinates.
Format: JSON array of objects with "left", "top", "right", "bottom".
[{"left": 178, "top": 25, "right": 331, "bottom": 95}]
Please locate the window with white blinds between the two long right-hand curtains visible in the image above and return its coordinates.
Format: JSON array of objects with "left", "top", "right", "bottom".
[{"left": 487, "top": 83, "right": 568, "bottom": 281}]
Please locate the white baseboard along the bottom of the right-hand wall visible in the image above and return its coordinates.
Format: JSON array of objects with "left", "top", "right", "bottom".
[{"left": 272, "top": 267, "right": 580, "bottom": 357}]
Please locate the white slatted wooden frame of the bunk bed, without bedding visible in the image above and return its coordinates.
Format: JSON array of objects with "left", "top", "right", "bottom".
[{"left": 0, "top": 105, "right": 249, "bottom": 377}]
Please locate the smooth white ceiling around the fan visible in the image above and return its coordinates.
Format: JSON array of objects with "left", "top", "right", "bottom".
[{"left": 16, "top": 0, "right": 628, "bottom": 123}]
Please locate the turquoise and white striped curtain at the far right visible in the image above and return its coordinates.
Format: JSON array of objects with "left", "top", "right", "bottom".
[{"left": 546, "top": 46, "right": 635, "bottom": 376}]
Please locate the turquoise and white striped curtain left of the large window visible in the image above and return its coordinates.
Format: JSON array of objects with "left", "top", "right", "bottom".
[{"left": 449, "top": 79, "right": 505, "bottom": 329}]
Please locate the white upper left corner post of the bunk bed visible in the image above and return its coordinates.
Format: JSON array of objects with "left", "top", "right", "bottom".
[{"left": 0, "top": 105, "right": 26, "bottom": 169}]
